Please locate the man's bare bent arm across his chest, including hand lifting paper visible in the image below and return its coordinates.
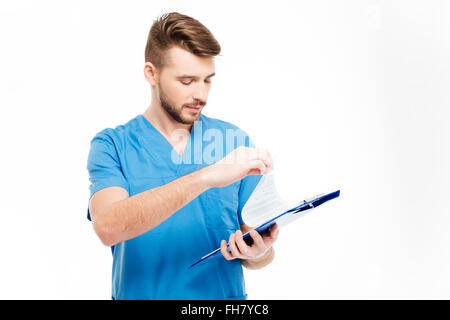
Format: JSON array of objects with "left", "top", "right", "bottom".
[{"left": 89, "top": 147, "right": 272, "bottom": 246}]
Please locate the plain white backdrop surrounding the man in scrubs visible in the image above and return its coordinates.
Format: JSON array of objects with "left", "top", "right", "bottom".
[{"left": 0, "top": 0, "right": 450, "bottom": 299}]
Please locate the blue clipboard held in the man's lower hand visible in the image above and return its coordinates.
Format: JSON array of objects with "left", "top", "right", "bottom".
[{"left": 189, "top": 190, "right": 341, "bottom": 269}]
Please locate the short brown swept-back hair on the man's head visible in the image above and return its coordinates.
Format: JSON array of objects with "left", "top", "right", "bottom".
[{"left": 145, "top": 12, "right": 220, "bottom": 68}]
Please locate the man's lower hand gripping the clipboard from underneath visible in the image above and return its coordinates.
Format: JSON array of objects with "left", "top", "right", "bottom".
[{"left": 220, "top": 224, "right": 279, "bottom": 269}]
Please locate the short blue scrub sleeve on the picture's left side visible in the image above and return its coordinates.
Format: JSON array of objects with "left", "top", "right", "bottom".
[{"left": 87, "top": 131, "right": 128, "bottom": 220}]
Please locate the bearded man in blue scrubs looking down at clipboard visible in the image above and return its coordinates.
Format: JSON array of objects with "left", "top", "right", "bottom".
[{"left": 87, "top": 13, "right": 278, "bottom": 299}]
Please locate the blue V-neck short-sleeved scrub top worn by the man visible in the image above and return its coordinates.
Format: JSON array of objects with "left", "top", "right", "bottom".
[{"left": 87, "top": 114, "right": 261, "bottom": 299}]
